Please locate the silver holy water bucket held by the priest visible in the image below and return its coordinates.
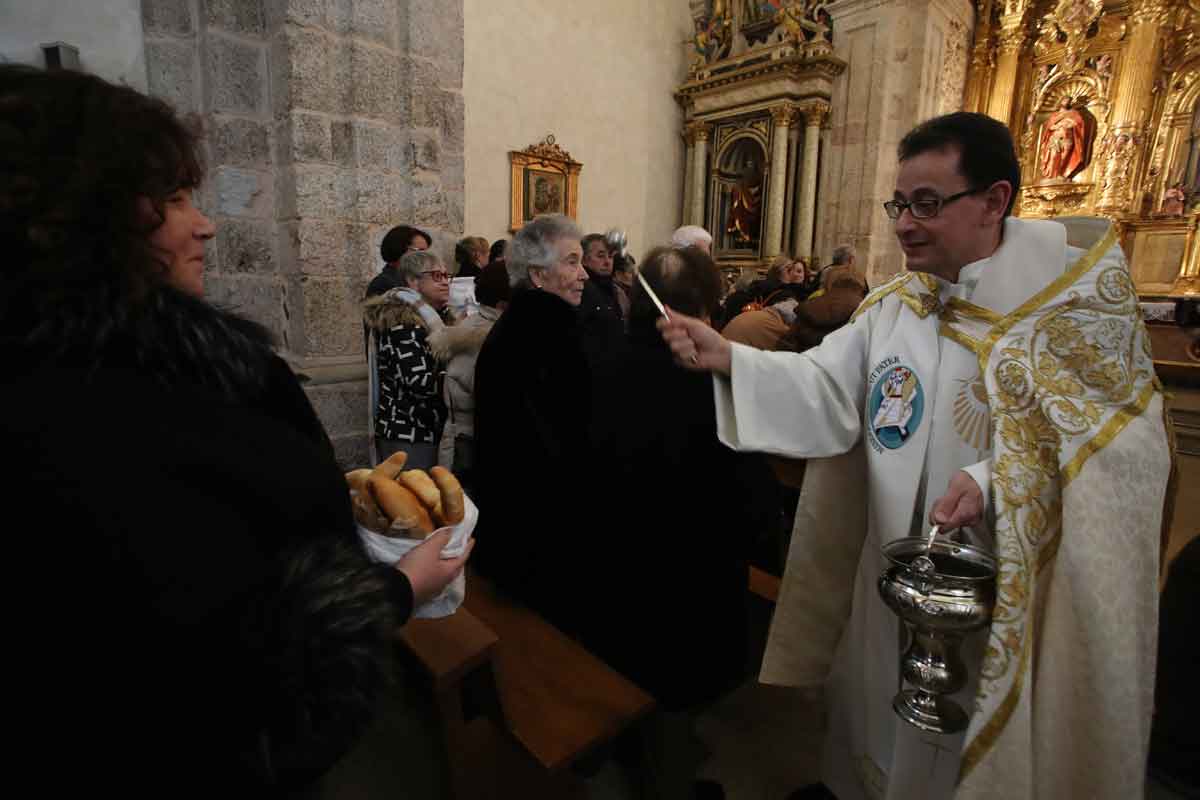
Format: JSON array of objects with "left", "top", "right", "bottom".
[{"left": 878, "top": 536, "right": 996, "bottom": 733}]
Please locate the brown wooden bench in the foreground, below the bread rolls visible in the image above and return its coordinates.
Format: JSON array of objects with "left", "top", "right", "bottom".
[{"left": 400, "top": 573, "right": 654, "bottom": 798}]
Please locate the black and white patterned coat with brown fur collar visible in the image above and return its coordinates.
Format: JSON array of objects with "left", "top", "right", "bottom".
[{"left": 362, "top": 290, "right": 452, "bottom": 444}]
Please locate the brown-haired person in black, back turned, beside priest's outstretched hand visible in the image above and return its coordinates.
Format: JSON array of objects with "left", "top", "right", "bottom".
[{"left": 584, "top": 247, "right": 775, "bottom": 796}]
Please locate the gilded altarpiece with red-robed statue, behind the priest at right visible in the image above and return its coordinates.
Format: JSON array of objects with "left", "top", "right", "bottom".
[{"left": 966, "top": 0, "right": 1200, "bottom": 383}]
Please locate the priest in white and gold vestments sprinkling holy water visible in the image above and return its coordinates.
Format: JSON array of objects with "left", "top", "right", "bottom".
[{"left": 660, "top": 113, "right": 1171, "bottom": 800}]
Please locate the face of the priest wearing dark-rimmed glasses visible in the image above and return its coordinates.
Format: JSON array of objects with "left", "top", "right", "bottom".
[{"left": 893, "top": 148, "right": 1008, "bottom": 282}]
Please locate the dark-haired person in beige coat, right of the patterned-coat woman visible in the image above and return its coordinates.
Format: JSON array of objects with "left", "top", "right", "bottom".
[{"left": 430, "top": 261, "right": 511, "bottom": 495}]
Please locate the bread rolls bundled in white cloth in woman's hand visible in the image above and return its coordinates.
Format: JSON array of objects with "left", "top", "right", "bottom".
[{"left": 346, "top": 451, "right": 479, "bottom": 619}]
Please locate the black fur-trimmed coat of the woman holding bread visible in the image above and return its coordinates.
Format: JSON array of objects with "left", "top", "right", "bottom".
[{"left": 0, "top": 288, "right": 412, "bottom": 798}]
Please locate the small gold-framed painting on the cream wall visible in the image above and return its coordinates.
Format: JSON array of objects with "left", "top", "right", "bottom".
[{"left": 509, "top": 136, "right": 583, "bottom": 233}]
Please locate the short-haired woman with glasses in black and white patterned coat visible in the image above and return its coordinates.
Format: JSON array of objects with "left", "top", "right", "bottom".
[{"left": 362, "top": 251, "right": 452, "bottom": 469}]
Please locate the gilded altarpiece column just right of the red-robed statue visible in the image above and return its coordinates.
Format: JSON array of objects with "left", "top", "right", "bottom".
[{"left": 1096, "top": 0, "right": 1174, "bottom": 213}]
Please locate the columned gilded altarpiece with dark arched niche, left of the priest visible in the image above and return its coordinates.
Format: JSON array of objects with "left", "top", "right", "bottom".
[{"left": 676, "top": 0, "right": 846, "bottom": 287}]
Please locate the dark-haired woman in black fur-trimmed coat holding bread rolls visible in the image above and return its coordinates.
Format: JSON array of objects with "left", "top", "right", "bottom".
[{"left": 0, "top": 65, "right": 462, "bottom": 798}]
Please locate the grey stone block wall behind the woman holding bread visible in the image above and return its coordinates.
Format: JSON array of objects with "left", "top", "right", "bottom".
[{"left": 142, "top": 0, "right": 464, "bottom": 467}]
